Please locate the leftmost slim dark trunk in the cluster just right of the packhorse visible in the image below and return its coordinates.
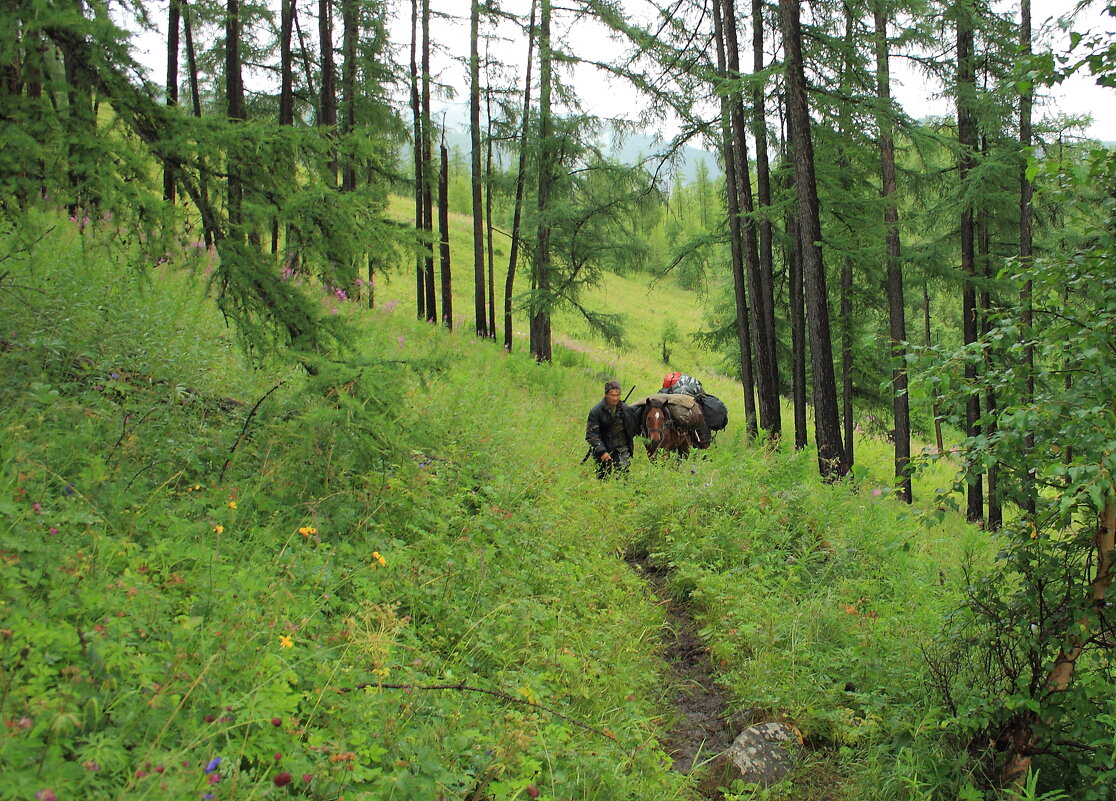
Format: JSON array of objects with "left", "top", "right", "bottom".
[{"left": 713, "top": 3, "right": 759, "bottom": 437}]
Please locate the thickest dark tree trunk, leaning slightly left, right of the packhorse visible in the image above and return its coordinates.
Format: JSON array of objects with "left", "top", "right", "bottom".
[{"left": 779, "top": 0, "right": 848, "bottom": 480}]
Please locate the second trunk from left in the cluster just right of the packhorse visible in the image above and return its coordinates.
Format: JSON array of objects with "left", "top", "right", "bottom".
[{"left": 721, "top": 0, "right": 780, "bottom": 438}]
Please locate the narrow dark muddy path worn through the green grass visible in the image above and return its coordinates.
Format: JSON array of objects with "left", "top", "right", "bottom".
[{"left": 625, "top": 554, "right": 737, "bottom": 785}]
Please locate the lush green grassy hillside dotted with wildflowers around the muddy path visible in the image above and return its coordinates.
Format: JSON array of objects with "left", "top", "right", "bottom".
[{"left": 0, "top": 209, "right": 988, "bottom": 801}]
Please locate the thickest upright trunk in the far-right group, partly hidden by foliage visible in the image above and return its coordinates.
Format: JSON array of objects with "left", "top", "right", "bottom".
[{"left": 956, "top": 0, "right": 984, "bottom": 521}]
